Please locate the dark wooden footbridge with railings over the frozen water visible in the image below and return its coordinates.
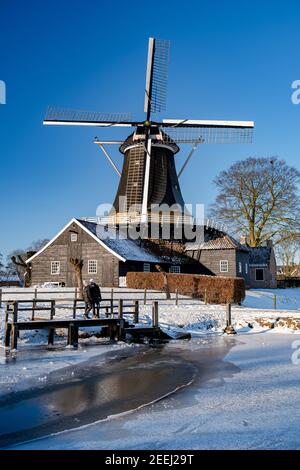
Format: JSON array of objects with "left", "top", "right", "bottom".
[{"left": 4, "top": 298, "right": 165, "bottom": 349}]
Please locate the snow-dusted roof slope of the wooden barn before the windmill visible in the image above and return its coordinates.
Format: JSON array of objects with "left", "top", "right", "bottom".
[{"left": 77, "top": 219, "right": 164, "bottom": 263}]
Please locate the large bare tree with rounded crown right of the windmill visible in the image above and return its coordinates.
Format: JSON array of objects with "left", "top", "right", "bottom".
[{"left": 211, "top": 157, "right": 300, "bottom": 247}]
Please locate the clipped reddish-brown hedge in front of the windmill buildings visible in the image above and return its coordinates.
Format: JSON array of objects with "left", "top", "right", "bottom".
[{"left": 126, "top": 272, "right": 245, "bottom": 304}]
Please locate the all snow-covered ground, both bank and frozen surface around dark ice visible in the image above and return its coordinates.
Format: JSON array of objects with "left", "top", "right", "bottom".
[{"left": 0, "top": 289, "right": 300, "bottom": 449}]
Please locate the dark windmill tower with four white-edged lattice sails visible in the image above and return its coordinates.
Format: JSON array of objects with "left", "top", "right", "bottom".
[{"left": 44, "top": 38, "right": 254, "bottom": 223}]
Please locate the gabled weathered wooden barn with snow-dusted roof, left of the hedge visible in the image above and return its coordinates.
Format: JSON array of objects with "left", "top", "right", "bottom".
[{"left": 27, "top": 219, "right": 207, "bottom": 287}]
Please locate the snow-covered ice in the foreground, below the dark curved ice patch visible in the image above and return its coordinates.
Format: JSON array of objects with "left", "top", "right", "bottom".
[{"left": 8, "top": 333, "right": 300, "bottom": 450}]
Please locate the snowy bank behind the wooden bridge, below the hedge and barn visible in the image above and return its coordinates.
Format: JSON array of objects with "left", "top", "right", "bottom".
[{"left": 0, "top": 289, "right": 300, "bottom": 347}]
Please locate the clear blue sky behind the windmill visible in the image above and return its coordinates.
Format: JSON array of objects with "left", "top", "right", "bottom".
[{"left": 0, "top": 0, "right": 300, "bottom": 254}]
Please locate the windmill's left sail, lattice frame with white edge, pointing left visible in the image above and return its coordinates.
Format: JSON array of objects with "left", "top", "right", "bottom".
[{"left": 44, "top": 107, "right": 136, "bottom": 127}]
